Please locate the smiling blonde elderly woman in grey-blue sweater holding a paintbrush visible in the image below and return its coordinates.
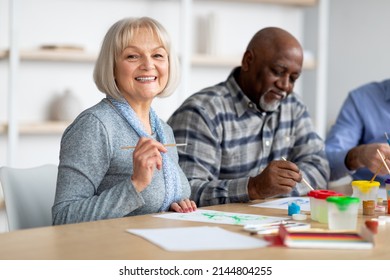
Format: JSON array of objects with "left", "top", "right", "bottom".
[{"left": 52, "top": 17, "right": 196, "bottom": 225}]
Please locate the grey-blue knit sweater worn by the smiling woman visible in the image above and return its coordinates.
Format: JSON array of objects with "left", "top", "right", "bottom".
[{"left": 52, "top": 99, "right": 190, "bottom": 225}]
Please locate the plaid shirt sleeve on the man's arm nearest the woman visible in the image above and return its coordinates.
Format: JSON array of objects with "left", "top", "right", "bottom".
[{"left": 168, "top": 93, "right": 249, "bottom": 206}]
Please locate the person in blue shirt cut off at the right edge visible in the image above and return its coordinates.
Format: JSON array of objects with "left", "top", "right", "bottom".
[{"left": 325, "top": 79, "right": 390, "bottom": 184}]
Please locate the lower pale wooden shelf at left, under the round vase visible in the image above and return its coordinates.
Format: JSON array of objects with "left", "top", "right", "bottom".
[{"left": 0, "top": 121, "right": 70, "bottom": 135}]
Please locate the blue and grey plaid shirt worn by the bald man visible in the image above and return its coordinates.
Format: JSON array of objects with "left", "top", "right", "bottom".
[{"left": 168, "top": 68, "right": 329, "bottom": 206}]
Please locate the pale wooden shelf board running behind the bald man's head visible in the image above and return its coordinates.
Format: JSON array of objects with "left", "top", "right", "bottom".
[{"left": 191, "top": 54, "right": 316, "bottom": 69}]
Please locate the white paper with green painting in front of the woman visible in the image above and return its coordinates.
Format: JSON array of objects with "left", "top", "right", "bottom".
[{"left": 154, "top": 209, "right": 289, "bottom": 226}]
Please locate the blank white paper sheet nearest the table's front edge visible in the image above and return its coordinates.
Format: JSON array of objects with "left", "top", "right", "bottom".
[{"left": 127, "top": 226, "right": 269, "bottom": 251}]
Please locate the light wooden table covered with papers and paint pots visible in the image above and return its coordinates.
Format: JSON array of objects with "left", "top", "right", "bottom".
[{"left": 0, "top": 201, "right": 390, "bottom": 260}]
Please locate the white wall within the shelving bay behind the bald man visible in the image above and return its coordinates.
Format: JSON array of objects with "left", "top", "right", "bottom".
[{"left": 187, "top": 1, "right": 304, "bottom": 95}]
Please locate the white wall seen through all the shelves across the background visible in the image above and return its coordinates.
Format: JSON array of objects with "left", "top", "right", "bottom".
[{"left": 0, "top": 0, "right": 310, "bottom": 167}]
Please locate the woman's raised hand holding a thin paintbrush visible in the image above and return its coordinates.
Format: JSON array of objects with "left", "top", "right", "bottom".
[{"left": 131, "top": 137, "right": 167, "bottom": 192}]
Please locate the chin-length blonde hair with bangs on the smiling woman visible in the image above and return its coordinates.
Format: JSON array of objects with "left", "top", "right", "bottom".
[{"left": 93, "top": 17, "right": 180, "bottom": 99}]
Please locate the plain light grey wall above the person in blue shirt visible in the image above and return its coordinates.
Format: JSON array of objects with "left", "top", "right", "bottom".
[{"left": 327, "top": 0, "right": 390, "bottom": 132}]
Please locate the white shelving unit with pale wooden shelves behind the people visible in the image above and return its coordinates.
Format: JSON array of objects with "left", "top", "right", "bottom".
[{"left": 0, "top": 0, "right": 327, "bottom": 165}]
